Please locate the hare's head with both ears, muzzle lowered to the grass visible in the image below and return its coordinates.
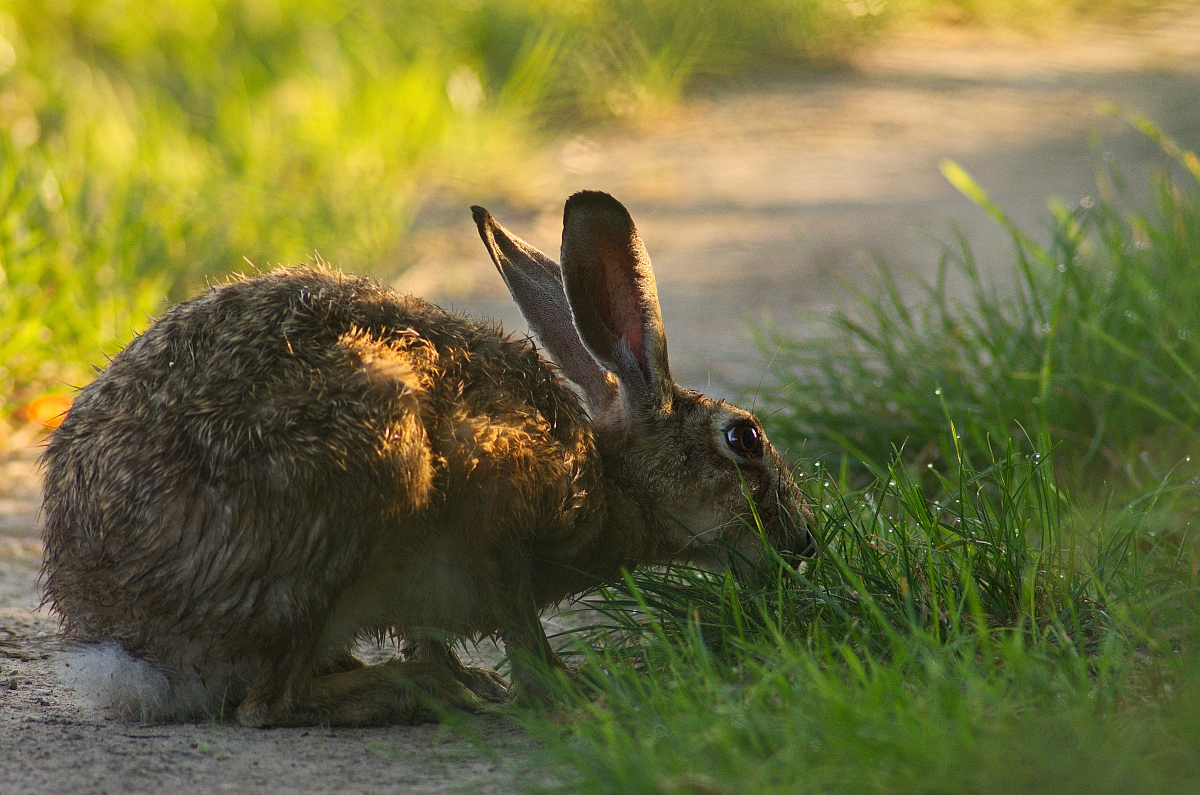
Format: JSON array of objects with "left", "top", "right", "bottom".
[{"left": 472, "top": 191, "right": 812, "bottom": 574}]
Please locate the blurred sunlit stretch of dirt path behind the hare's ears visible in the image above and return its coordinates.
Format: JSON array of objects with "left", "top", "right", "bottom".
[{"left": 398, "top": 5, "right": 1200, "bottom": 391}]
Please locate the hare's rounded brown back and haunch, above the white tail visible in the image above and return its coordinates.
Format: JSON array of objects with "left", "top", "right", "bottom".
[{"left": 44, "top": 269, "right": 504, "bottom": 647}]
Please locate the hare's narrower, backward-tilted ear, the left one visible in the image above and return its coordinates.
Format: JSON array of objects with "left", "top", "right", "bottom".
[{"left": 470, "top": 207, "right": 617, "bottom": 416}]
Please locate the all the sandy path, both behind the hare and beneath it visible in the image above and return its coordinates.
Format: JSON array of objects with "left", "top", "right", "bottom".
[{"left": 0, "top": 6, "right": 1200, "bottom": 795}]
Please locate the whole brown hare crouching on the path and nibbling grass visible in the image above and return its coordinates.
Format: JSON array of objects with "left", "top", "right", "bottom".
[{"left": 43, "top": 192, "right": 811, "bottom": 727}]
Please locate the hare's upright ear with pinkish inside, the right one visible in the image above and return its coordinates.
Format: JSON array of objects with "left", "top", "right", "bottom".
[{"left": 563, "top": 191, "right": 671, "bottom": 408}]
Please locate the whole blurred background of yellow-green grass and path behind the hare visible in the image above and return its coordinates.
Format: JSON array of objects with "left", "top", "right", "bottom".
[{"left": 0, "top": 0, "right": 1200, "bottom": 419}]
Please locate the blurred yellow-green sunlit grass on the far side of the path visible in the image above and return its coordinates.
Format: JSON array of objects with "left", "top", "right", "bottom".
[{"left": 0, "top": 0, "right": 1171, "bottom": 416}]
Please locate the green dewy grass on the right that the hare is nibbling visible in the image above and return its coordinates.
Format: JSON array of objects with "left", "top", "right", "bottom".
[{"left": 524, "top": 119, "right": 1200, "bottom": 794}]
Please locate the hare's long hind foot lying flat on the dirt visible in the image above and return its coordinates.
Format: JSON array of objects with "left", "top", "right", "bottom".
[{"left": 238, "top": 660, "right": 478, "bottom": 727}]
